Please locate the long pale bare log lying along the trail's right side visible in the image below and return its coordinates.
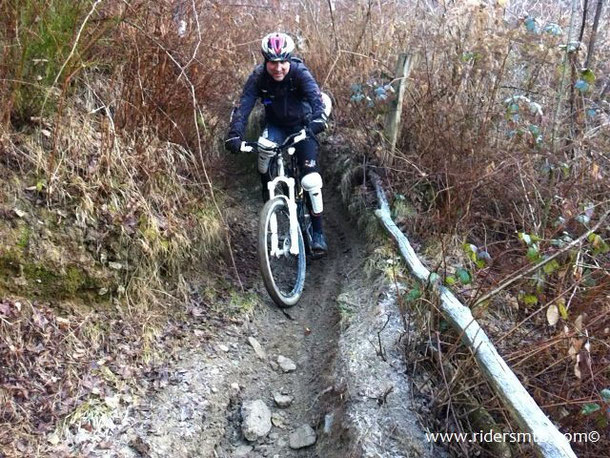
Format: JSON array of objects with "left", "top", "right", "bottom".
[{"left": 369, "top": 171, "right": 576, "bottom": 458}]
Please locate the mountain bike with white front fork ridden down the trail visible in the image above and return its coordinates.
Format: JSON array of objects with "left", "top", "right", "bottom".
[{"left": 241, "top": 129, "right": 312, "bottom": 307}]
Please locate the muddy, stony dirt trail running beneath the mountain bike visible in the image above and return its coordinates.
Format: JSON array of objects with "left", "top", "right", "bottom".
[{"left": 70, "top": 144, "right": 438, "bottom": 458}]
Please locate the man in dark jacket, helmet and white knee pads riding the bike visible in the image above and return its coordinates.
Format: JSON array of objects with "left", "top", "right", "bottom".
[{"left": 225, "top": 32, "right": 328, "bottom": 255}]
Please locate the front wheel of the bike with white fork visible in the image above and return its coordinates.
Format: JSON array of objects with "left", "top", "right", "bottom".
[{"left": 258, "top": 197, "right": 306, "bottom": 307}]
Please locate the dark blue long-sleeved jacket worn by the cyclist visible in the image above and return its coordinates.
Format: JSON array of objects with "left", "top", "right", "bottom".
[{"left": 227, "top": 58, "right": 325, "bottom": 139}]
